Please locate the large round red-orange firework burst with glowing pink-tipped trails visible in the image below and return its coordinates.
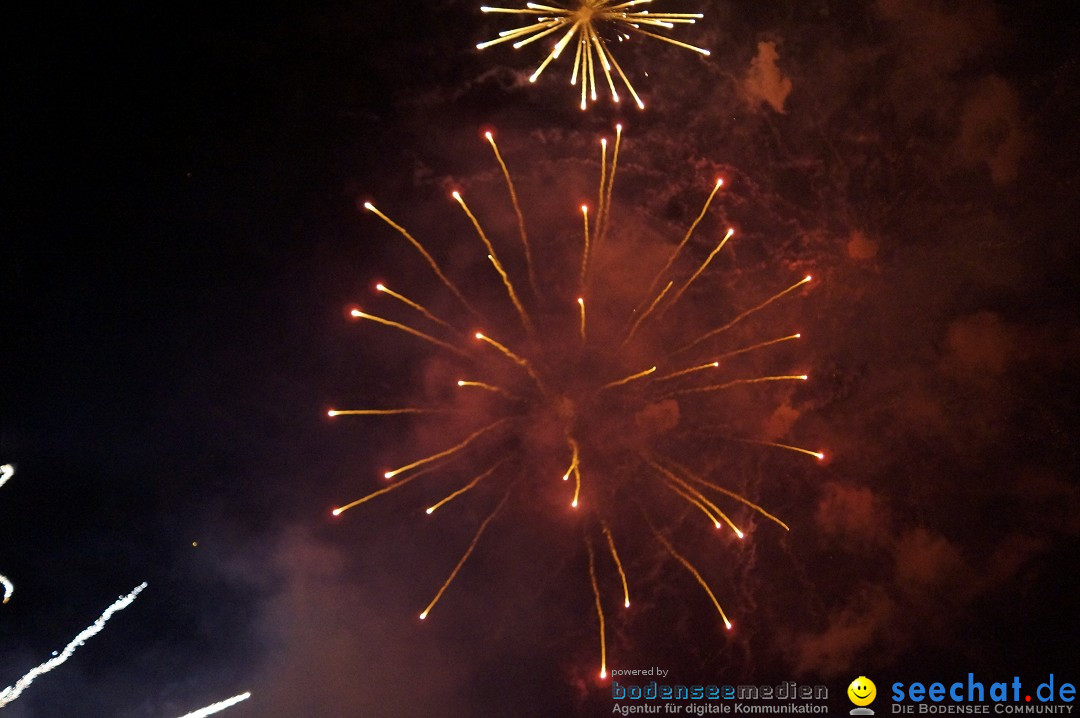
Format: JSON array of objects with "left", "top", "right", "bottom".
[{"left": 328, "top": 127, "right": 824, "bottom": 678}]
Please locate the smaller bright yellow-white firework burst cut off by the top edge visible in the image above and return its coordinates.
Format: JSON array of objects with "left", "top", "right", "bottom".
[{"left": 476, "top": 0, "right": 708, "bottom": 110}]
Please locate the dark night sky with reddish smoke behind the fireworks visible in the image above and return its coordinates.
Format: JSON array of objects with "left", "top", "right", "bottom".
[{"left": 0, "top": 0, "right": 1080, "bottom": 718}]
